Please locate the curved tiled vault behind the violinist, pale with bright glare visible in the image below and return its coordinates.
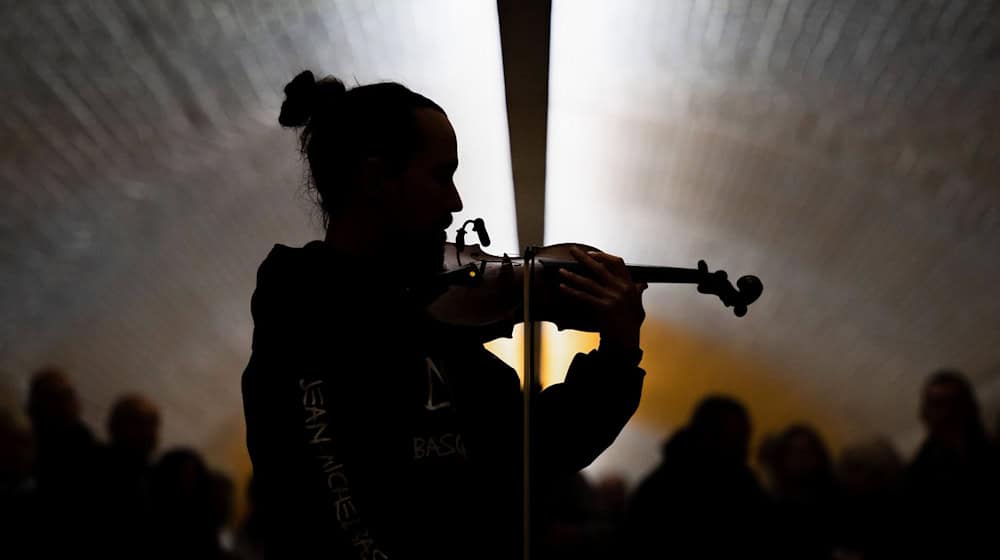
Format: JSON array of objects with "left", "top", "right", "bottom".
[{"left": 0, "top": 0, "right": 1000, "bottom": 484}]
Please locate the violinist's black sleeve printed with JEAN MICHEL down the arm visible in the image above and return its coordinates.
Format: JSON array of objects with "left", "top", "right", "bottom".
[{"left": 242, "top": 250, "right": 395, "bottom": 560}]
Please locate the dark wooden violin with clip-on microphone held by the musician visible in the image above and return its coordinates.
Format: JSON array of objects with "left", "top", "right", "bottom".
[{"left": 418, "top": 218, "right": 763, "bottom": 341}]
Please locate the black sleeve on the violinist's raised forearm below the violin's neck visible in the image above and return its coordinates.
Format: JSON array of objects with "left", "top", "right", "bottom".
[{"left": 532, "top": 346, "right": 645, "bottom": 474}]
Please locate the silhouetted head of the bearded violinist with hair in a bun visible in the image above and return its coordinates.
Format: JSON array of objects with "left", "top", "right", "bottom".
[{"left": 279, "top": 71, "right": 462, "bottom": 278}]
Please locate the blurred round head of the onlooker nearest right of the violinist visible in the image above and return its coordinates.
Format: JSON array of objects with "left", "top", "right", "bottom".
[{"left": 688, "top": 395, "right": 751, "bottom": 463}]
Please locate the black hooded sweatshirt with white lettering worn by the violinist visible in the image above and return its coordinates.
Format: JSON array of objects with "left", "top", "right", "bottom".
[{"left": 243, "top": 241, "right": 644, "bottom": 558}]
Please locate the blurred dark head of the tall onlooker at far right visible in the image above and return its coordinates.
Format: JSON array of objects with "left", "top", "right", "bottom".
[{"left": 920, "top": 369, "right": 986, "bottom": 445}]
